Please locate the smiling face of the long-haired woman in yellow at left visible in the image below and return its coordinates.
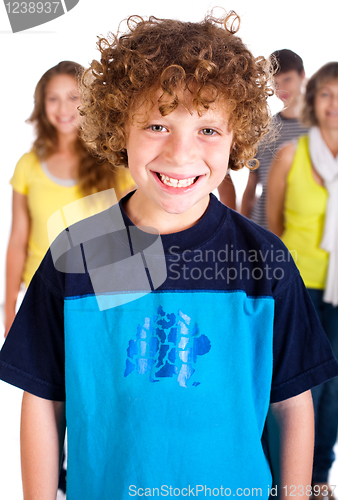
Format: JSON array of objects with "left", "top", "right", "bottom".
[{"left": 45, "top": 75, "right": 81, "bottom": 136}]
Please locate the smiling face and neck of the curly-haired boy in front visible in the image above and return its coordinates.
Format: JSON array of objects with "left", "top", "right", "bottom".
[{"left": 126, "top": 94, "right": 233, "bottom": 232}]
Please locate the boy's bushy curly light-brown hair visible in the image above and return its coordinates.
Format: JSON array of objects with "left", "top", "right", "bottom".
[{"left": 80, "top": 11, "right": 273, "bottom": 170}]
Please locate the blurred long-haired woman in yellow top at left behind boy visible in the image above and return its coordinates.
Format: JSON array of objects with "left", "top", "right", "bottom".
[{"left": 5, "top": 61, "right": 134, "bottom": 336}]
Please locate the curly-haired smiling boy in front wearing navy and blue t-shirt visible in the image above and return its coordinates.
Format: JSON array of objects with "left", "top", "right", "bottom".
[{"left": 0, "top": 14, "right": 338, "bottom": 500}]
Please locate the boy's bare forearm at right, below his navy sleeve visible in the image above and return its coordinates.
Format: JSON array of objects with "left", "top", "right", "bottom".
[{"left": 267, "top": 391, "right": 314, "bottom": 499}]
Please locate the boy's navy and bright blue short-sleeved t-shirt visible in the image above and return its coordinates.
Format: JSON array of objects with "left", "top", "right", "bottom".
[{"left": 0, "top": 195, "right": 338, "bottom": 500}]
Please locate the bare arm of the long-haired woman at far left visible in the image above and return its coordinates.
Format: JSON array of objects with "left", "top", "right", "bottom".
[{"left": 5, "top": 191, "right": 30, "bottom": 337}]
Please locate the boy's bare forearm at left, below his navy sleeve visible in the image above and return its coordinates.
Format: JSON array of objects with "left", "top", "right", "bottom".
[{"left": 21, "top": 392, "right": 65, "bottom": 500}]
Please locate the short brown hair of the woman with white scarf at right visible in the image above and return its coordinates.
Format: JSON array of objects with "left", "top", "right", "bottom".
[{"left": 301, "top": 61, "right": 338, "bottom": 127}]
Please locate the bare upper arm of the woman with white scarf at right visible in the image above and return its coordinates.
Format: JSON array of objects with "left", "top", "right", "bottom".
[{"left": 266, "top": 143, "right": 295, "bottom": 236}]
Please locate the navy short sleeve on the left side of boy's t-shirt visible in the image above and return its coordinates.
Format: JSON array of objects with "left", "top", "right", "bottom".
[{"left": 0, "top": 253, "right": 65, "bottom": 401}]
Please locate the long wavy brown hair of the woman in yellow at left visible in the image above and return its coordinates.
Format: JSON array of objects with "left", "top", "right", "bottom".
[{"left": 27, "top": 61, "right": 114, "bottom": 195}]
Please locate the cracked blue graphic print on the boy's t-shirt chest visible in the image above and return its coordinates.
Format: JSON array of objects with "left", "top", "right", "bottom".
[{"left": 124, "top": 306, "right": 211, "bottom": 387}]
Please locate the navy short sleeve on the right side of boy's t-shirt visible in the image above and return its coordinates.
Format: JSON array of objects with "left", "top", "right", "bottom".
[{"left": 271, "top": 273, "right": 338, "bottom": 403}]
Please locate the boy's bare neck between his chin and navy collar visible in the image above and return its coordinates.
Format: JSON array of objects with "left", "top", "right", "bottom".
[{"left": 123, "top": 190, "right": 210, "bottom": 234}]
